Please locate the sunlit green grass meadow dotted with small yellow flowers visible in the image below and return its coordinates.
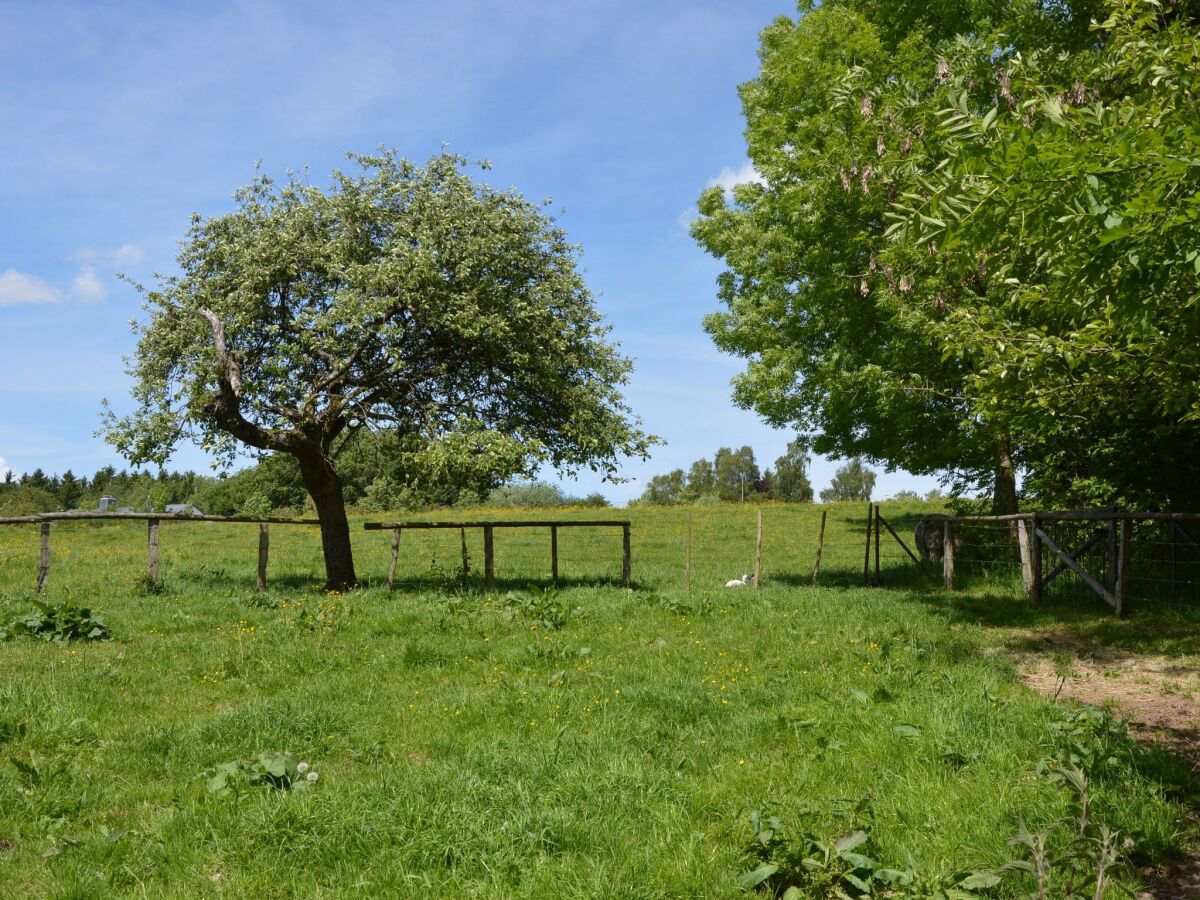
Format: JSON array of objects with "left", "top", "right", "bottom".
[{"left": 0, "top": 506, "right": 1198, "bottom": 898}]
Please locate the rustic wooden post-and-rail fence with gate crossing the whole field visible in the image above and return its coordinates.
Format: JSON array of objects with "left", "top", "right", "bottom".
[{"left": 0, "top": 503, "right": 1200, "bottom": 612}]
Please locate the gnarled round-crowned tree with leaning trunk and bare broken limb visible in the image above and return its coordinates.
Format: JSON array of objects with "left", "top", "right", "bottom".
[{"left": 106, "top": 151, "right": 653, "bottom": 589}]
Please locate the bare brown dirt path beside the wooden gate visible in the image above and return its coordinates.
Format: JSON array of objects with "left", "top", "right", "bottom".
[{"left": 1012, "top": 630, "right": 1200, "bottom": 900}]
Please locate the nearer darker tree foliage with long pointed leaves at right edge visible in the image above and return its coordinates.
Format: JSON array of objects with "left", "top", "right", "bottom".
[{"left": 880, "top": 0, "right": 1200, "bottom": 509}]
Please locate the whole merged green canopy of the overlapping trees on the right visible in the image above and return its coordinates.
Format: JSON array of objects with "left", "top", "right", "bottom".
[{"left": 694, "top": 0, "right": 1200, "bottom": 510}]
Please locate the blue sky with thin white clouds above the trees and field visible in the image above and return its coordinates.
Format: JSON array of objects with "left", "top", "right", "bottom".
[{"left": 0, "top": 0, "right": 935, "bottom": 500}]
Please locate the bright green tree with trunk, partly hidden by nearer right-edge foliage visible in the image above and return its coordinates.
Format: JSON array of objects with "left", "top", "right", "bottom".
[{"left": 694, "top": 0, "right": 1094, "bottom": 510}]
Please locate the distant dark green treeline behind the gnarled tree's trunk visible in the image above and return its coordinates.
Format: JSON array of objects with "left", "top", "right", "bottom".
[{"left": 0, "top": 451, "right": 608, "bottom": 516}]
